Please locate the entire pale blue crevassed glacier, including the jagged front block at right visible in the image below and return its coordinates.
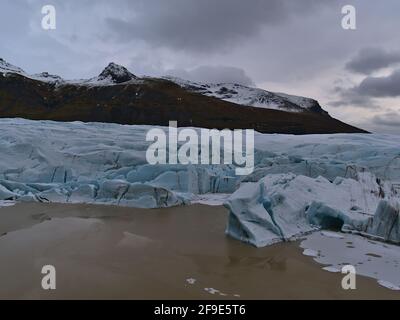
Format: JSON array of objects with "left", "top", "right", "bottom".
[{"left": 0, "top": 119, "right": 400, "bottom": 247}]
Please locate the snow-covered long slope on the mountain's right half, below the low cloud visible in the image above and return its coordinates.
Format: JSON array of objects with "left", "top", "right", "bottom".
[{"left": 165, "top": 77, "right": 326, "bottom": 114}]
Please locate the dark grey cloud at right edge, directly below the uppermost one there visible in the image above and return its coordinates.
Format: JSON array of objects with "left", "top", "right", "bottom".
[{"left": 354, "top": 69, "right": 400, "bottom": 97}]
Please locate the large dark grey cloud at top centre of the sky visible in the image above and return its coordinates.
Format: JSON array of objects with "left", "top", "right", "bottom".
[{"left": 106, "top": 0, "right": 336, "bottom": 52}]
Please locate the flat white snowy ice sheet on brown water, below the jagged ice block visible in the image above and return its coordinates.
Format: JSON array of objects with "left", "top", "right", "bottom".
[{"left": 300, "top": 232, "right": 400, "bottom": 290}]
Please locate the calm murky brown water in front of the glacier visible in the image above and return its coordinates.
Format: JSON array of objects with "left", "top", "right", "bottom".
[{"left": 0, "top": 203, "right": 400, "bottom": 299}]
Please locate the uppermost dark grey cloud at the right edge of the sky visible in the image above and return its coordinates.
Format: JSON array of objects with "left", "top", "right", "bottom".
[{"left": 346, "top": 48, "right": 400, "bottom": 74}]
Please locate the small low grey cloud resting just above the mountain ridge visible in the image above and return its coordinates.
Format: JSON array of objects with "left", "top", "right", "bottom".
[{"left": 167, "top": 66, "right": 254, "bottom": 86}]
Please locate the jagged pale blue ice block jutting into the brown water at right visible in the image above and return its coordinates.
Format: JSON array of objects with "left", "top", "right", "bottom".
[{"left": 225, "top": 172, "right": 400, "bottom": 247}]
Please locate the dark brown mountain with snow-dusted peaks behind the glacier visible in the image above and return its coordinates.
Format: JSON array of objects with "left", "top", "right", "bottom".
[{"left": 0, "top": 59, "right": 365, "bottom": 134}]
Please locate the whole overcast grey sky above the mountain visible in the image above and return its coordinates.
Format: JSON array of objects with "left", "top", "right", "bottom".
[{"left": 0, "top": 0, "right": 400, "bottom": 134}]
